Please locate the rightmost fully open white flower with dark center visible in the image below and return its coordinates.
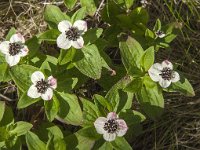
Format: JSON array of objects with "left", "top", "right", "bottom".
[{"left": 148, "top": 60, "right": 180, "bottom": 88}]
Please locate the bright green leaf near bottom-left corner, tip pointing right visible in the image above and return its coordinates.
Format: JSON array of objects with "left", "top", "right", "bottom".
[{"left": 9, "top": 121, "right": 33, "bottom": 136}]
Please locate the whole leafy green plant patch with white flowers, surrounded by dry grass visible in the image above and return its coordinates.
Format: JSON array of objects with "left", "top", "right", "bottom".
[{"left": 0, "top": 0, "right": 195, "bottom": 150}]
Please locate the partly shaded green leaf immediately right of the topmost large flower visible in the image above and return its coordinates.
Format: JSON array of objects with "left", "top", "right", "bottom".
[{"left": 83, "top": 28, "right": 103, "bottom": 45}]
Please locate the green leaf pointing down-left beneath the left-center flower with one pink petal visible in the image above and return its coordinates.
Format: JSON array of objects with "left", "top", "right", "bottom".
[{"left": 17, "top": 92, "right": 41, "bottom": 109}]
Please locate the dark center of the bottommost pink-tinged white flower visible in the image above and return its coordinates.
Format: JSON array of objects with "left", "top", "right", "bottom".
[{"left": 103, "top": 119, "right": 119, "bottom": 133}]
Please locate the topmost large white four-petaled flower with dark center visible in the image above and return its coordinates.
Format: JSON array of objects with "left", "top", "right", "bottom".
[{"left": 57, "top": 20, "right": 87, "bottom": 49}]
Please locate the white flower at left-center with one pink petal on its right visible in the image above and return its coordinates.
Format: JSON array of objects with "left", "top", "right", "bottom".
[{"left": 27, "top": 71, "right": 57, "bottom": 100}]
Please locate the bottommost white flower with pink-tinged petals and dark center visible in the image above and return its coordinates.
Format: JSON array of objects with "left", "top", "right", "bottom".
[{"left": 94, "top": 112, "right": 128, "bottom": 142}]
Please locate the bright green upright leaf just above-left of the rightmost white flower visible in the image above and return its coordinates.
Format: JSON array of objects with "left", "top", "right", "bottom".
[{"left": 141, "top": 46, "right": 154, "bottom": 71}]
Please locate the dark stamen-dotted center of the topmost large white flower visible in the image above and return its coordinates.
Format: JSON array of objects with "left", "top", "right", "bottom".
[{"left": 65, "top": 27, "right": 81, "bottom": 41}]
